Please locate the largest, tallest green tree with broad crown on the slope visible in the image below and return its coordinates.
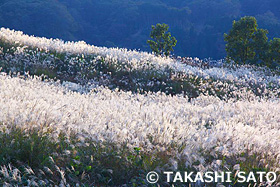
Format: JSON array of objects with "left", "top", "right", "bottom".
[{"left": 224, "top": 16, "right": 269, "bottom": 64}]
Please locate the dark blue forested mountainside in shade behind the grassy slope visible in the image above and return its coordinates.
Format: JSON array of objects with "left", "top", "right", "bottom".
[{"left": 0, "top": 0, "right": 280, "bottom": 59}]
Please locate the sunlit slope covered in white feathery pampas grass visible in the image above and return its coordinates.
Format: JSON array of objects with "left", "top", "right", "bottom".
[{"left": 0, "top": 28, "right": 280, "bottom": 186}]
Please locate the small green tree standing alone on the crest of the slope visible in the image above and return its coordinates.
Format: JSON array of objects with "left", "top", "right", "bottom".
[{"left": 147, "top": 23, "right": 177, "bottom": 56}]
